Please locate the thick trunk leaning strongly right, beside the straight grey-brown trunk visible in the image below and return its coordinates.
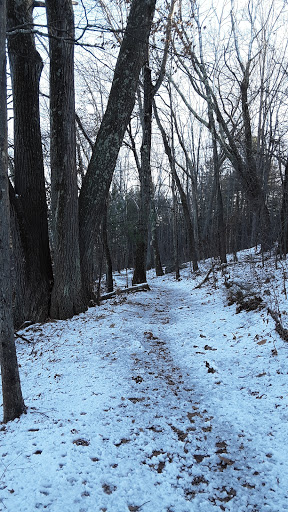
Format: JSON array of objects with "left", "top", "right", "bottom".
[{"left": 79, "top": 0, "right": 156, "bottom": 300}]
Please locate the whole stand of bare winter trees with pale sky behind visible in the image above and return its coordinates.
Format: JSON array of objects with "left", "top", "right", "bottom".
[{"left": 0, "top": 0, "right": 288, "bottom": 421}]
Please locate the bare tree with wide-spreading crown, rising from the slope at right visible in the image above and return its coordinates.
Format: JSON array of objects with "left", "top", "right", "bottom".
[{"left": 171, "top": 0, "right": 283, "bottom": 250}]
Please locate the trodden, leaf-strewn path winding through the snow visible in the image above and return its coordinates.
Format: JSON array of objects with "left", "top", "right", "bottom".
[{"left": 115, "top": 283, "right": 285, "bottom": 511}]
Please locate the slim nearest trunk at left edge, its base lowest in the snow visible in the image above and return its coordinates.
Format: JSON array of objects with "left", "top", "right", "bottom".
[{"left": 0, "top": 0, "right": 25, "bottom": 423}]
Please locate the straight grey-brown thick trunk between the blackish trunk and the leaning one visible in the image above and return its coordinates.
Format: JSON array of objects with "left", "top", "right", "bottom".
[{"left": 46, "top": 0, "right": 85, "bottom": 319}]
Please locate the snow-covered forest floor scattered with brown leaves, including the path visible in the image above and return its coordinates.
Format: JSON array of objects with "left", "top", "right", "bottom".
[{"left": 0, "top": 251, "right": 288, "bottom": 512}]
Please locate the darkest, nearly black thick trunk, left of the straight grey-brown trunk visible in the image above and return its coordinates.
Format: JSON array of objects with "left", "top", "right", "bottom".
[{"left": 7, "top": 0, "right": 53, "bottom": 321}]
